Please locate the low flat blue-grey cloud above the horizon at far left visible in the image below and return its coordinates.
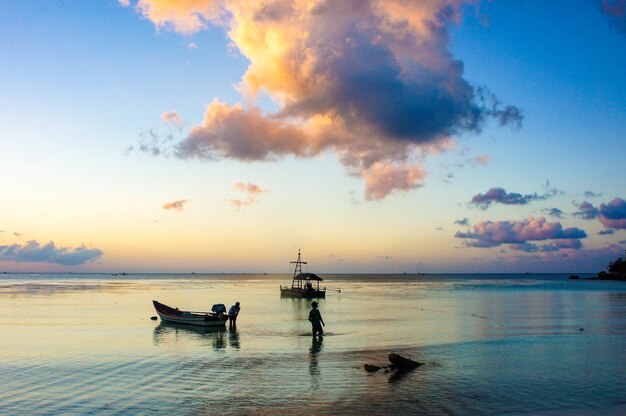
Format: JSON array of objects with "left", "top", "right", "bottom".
[{"left": 0, "top": 240, "right": 104, "bottom": 266}]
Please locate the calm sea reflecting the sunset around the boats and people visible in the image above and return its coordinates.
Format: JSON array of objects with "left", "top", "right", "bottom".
[{"left": 0, "top": 273, "right": 626, "bottom": 415}]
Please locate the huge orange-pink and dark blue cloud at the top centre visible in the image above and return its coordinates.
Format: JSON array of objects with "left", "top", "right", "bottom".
[{"left": 124, "top": 0, "right": 522, "bottom": 199}]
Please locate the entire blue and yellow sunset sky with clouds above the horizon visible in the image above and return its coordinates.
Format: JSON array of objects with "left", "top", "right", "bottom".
[{"left": 0, "top": 0, "right": 626, "bottom": 273}]
